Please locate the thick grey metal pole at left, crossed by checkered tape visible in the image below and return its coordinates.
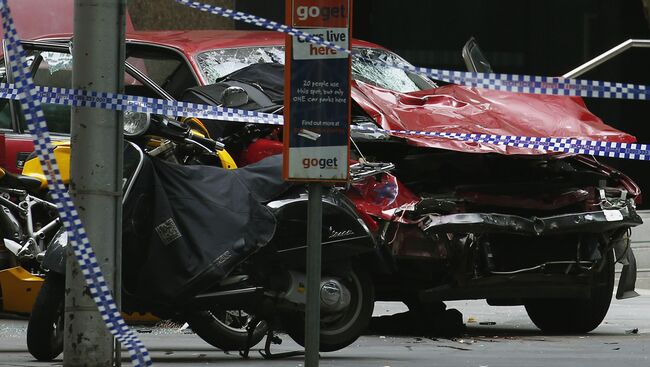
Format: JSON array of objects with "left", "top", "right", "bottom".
[{"left": 63, "top": 0, "right": 126, "bottom": 367}]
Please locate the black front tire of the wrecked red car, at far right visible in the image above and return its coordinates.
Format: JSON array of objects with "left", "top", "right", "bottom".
[{"left": 524, "top": 251, "right": 615, "bottom": 334}]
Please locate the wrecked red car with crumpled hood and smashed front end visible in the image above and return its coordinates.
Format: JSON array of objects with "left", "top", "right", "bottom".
[{"left": 6, "top": 31, "right": 641, "bottom": 332}]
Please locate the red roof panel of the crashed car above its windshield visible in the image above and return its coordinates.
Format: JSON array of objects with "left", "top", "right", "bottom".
[{"left": 40, "top": 30, "right": 383, "bottom": 57}]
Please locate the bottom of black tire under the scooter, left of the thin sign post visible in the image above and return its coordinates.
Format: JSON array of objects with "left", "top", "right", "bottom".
[{"left": 186, "top": 309, "right": 268, "bottom": 350}]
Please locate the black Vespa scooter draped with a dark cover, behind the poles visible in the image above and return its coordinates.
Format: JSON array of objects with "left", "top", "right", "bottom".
[{"left": 21, "top": 115, "right": 375, "bottom": 360}]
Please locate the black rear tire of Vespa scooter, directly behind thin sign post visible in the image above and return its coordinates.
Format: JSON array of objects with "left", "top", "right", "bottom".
[{"left": 282, "top": 269, "right": 375, "bottom": 352}]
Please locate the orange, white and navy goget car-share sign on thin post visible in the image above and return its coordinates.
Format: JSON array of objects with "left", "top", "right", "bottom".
[{"left": 284, "top": 0, "right": 352, "bottom": 182}]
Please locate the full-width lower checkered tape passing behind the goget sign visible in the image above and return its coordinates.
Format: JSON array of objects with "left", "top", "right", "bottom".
[{"left": 0, "top": 79, "right": 650, "bottom": 160}]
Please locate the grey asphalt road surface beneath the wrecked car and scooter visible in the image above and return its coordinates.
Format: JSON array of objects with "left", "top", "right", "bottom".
[{"left": 0, "top": 291, "right": 650, "bottom": 367}]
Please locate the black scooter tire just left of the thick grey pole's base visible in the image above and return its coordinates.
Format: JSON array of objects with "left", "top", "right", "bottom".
[{"left": 27, "top": 273, "right": 65, "bottom": 361}]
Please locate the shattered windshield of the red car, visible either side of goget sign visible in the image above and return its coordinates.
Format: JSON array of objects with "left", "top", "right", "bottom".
[{"left": 196, "top": 46, "right": 436, "bottom": 93}]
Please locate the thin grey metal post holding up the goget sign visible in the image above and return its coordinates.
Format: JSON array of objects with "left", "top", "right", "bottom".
[{"left": 305, "top": 183, "right": 323, "bottom": 367}]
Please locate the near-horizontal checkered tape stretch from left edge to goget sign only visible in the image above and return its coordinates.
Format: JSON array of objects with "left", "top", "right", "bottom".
[{"left": 0, "top": 83, "right": 282, "bottom": 125}]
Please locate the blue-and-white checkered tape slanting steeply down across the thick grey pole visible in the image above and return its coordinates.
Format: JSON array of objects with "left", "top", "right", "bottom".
[{"left": 0, "top": 0, "right": 152, "bottom": 366}]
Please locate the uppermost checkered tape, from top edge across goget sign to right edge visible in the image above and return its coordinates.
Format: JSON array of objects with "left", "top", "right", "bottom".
[{"left": 175, "top": 0, "right": 650, "bottom": 100}]
